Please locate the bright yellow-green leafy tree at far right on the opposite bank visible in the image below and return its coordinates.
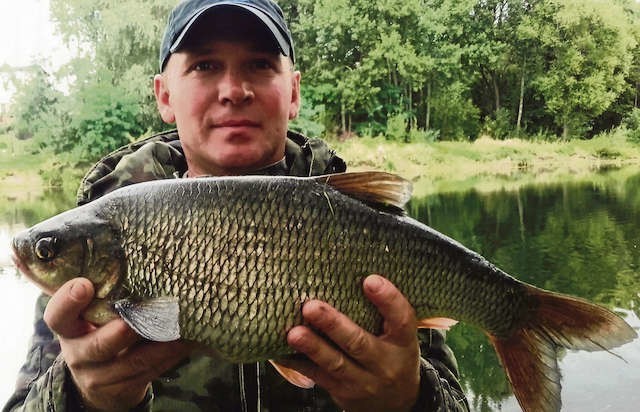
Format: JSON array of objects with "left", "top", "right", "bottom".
[{"left": 535, "top": 0, "right": 637, "bottom": 139}]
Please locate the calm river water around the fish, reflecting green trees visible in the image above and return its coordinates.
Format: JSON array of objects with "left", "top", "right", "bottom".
[{"left": 0, "top": 171, "right": 640, "bottom": 412}]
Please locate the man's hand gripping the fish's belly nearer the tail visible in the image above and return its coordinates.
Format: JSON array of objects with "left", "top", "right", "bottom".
[{"left": 283, "top": 275, "right": 420, "bottom": 412}]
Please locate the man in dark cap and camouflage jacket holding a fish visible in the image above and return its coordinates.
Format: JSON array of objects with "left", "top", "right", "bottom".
[{"left": 5, "top": 0, "right": 467, "bottom": 411}]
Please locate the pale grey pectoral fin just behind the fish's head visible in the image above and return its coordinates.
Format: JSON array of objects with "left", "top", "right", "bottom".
[{"left": 114, "top": 297, "right": 180, "bottom": 342}]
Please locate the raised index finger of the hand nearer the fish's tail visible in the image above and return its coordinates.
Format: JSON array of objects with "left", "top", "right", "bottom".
[{"left": 363, "top": 275, "right": 417, "bottom": 344}]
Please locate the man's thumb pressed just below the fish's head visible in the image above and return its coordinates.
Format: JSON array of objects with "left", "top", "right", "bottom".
[{"left": 44, "top": 278, "right": 94, "bottom": 339}]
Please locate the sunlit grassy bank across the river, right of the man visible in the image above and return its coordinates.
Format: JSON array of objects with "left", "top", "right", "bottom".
[{"left": 332, "top": 132, "right": 640, "bottom": 197}]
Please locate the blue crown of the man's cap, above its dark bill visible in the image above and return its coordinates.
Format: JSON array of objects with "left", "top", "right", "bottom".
[{"left": 160, "top": 0, "right": 294, "bottom": 71}]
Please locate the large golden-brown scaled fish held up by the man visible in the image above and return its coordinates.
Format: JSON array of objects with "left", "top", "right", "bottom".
[{"left": 13, "top": 172, "right": 637, "bottom": 411}]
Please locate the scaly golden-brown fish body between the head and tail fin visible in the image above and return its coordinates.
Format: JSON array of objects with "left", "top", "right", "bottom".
[{"left": 116, "top": 178, "right": 527, "bottom": 361}]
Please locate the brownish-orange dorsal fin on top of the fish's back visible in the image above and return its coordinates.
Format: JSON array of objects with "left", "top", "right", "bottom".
[{"left": 313, "top": 172, "right": 412, "bottom": 214}]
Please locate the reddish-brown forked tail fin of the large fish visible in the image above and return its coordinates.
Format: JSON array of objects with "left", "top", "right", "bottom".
[{"left": 489, "top": 287, "right": 637, "bottom": 412}]
